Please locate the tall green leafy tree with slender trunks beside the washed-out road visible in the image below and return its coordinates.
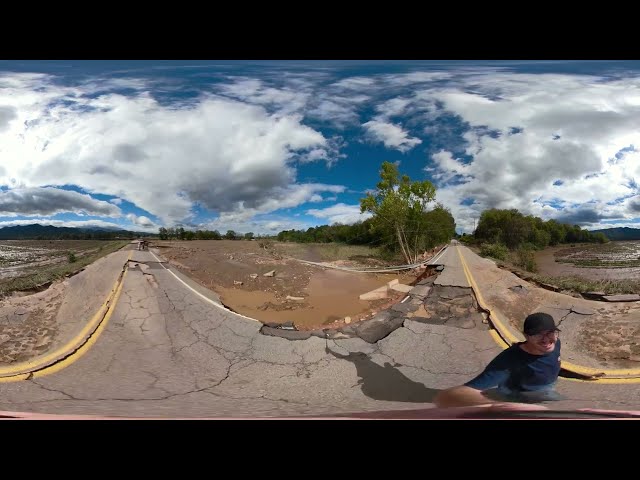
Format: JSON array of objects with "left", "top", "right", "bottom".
[{"left": 360, "top": 162, "right": 436, "bottom": 263}]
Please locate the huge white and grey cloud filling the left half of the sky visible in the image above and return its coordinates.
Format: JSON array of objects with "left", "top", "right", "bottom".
[{"left": 0, "top": 75, "right": 343, "bottom": 229}]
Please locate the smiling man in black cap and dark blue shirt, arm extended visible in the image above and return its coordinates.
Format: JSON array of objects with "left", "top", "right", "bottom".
[{"left": 434, "top": 312, "right": 562, "bottom": 408}]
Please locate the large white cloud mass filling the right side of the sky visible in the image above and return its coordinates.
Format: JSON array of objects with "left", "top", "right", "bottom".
[{"left": 408, "top": 72, "right": 640, "bottom": 231}]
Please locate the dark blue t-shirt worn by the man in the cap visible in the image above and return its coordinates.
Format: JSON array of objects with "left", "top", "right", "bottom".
[{"left": 465, "top": 339, "right": 560, "bottom": 392}]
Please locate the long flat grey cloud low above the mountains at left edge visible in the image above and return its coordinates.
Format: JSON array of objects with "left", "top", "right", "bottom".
[{"left": 0, "top": 187, "right": 121, "bottom": 217}]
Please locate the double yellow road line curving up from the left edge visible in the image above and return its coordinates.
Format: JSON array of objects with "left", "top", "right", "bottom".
[{"left": 0, "top": 252, "right": 133, "bottom": 383}]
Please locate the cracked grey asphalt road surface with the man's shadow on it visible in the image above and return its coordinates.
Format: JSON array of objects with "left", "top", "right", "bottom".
[{"left": 0, "top": 244, "right": 640, "bottom": 418}]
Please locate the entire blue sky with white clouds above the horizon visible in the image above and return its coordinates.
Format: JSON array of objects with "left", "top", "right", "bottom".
[{"left": 0, "top": 60, "right": 640, "bottom": 234}]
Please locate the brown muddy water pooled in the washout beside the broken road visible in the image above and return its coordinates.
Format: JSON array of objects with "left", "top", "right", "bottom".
[{"left": 216, "top": 270, "right": 415, "bottom": 326}]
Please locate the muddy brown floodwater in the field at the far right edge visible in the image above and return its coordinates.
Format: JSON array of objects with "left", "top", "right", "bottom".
[{"left": 535, "top": 242, "right": 640, "bottom": 280}]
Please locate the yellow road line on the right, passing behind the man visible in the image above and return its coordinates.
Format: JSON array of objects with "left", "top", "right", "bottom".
[{"left": 456, "top": 246, "right": 640, "bottom": 384}]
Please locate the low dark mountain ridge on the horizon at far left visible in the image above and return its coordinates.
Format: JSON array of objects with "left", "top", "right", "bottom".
[{"left": 0, "top": 223, "right": 150, "bottom": 240}]
